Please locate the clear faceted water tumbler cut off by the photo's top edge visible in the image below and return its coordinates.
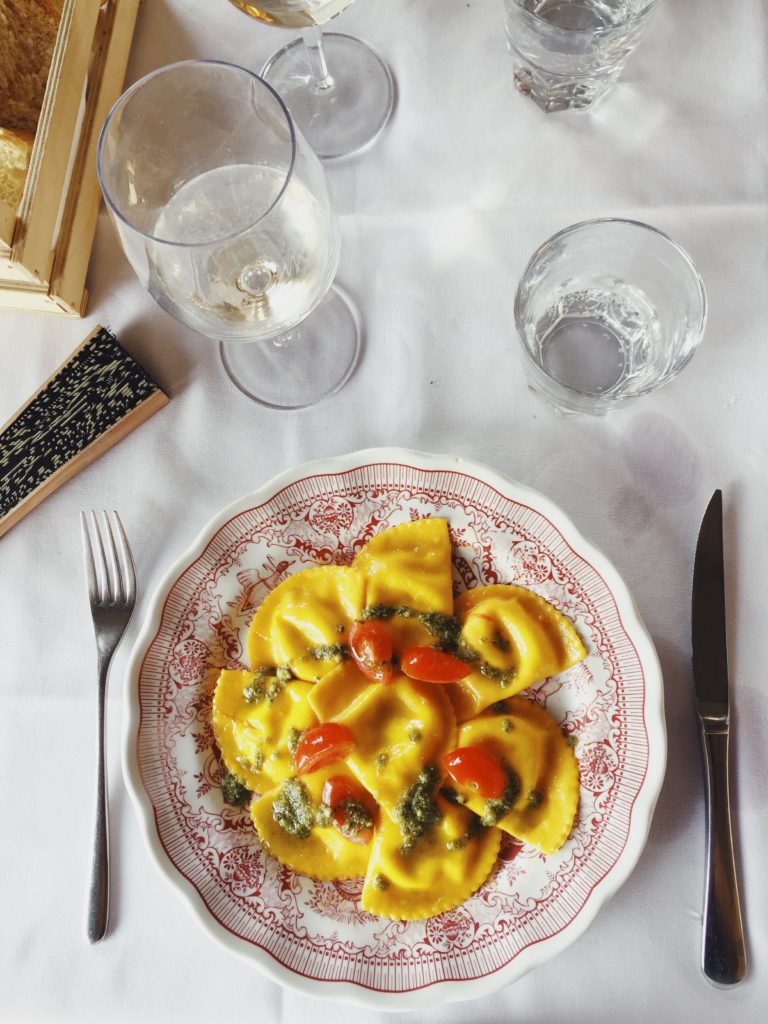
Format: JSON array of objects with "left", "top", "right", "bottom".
[{"left": 504, "top": 0, "right": 658, "bottom": 113}]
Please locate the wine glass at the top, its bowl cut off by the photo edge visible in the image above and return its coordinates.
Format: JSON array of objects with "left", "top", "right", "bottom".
[{"left": 230, "top": 0, "right": 394, "bottom": 160}]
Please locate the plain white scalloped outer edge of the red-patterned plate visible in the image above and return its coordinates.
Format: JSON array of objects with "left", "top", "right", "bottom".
[{"left": 123, "top": 449, "right": 667, "bottom": 1011}]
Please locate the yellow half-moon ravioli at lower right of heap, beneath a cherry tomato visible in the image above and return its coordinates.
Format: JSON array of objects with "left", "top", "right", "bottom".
[{"left": 453, "top": 697, "right": 579, "bottom": 853}]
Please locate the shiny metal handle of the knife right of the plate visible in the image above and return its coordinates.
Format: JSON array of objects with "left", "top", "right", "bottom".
[{"left": 701, "top": 720, "right": 746, "bottom": 985}]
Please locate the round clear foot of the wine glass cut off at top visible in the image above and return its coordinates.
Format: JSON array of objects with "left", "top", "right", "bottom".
[{"left": 261, "top": 32, "right": 394, "bottom": 160}]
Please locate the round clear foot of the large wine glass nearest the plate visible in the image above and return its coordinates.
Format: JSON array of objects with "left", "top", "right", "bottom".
[{"left": 219, "top": 285, "right": 362, "bottom": 409}]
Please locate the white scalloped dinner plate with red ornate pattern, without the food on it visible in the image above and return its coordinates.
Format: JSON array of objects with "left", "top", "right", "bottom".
[{"left": 124, "top": 449, "right": 666, "bottom": 1010}]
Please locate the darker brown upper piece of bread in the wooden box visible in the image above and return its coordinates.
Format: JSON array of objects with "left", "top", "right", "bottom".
[{"left": 0, "top": 0, "right": 60, "bottom": 132}]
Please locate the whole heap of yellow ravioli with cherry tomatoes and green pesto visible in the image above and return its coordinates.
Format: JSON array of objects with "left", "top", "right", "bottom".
[{"left": 212, "top": 518, "right": 586, "bottom": 921}]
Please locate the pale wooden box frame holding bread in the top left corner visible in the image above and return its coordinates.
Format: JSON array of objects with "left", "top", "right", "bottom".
[{"left": 0, "top": 0, "right": 139, "bottom": 316}]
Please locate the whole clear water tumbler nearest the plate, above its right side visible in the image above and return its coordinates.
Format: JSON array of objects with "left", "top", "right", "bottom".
[{"left": 515, "top": 218, "right": 707, "bottom": 414}]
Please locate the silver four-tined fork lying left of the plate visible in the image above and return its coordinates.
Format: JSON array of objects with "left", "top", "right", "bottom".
[{"left": 80, "top": 512, "right": 136, "bottom": 942}]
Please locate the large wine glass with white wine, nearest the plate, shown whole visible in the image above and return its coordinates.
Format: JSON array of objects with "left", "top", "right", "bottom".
[{"left": 97, "top": 60, "right": 360, "bottom": 409}]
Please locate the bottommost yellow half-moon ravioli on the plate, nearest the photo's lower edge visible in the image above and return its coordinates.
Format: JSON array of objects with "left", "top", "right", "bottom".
[{"left": 362, "top": 796, "right": 502, "bottom": 921}]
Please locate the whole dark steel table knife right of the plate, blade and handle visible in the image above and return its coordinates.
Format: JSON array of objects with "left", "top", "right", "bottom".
[{"left": 691, "top": 490, "right": 746, "bottom": 986}]
